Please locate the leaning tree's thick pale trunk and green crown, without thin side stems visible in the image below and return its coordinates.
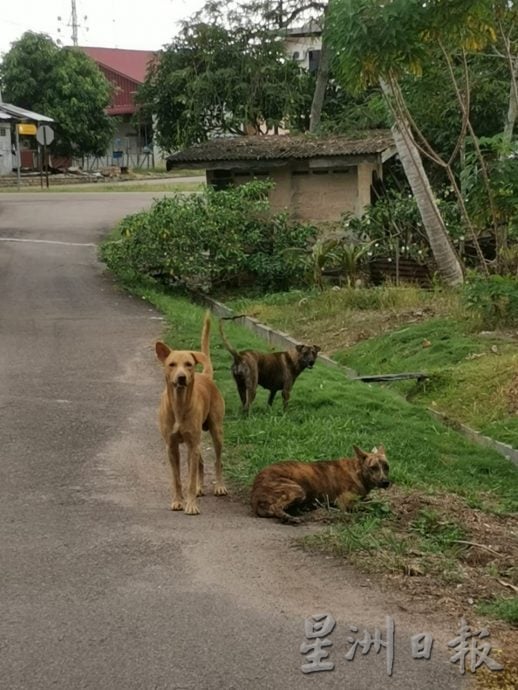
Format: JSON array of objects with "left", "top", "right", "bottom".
[{"left": 325, "top": 0, "right": 498, "bottom": 286}]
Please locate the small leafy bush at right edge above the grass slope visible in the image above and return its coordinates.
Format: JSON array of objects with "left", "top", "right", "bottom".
[{"left": 464, "top": 275, "right": 518, "bottom": 328}]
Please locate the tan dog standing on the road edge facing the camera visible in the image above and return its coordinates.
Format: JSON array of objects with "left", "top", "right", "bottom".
[{"left": 155, "top": 312, "right": 227, "bottom": 515}]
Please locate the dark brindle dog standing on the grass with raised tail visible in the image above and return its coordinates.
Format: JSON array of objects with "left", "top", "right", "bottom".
[{"left": 219, "top": 319, "right": 320, "bottom": 412}]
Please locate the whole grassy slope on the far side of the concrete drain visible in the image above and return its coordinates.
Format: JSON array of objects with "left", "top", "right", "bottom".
[{"left": 229, "top": 287, "right": 518, "bottom": 448}]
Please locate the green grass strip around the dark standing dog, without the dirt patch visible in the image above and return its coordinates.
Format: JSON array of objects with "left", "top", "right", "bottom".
[{"left": 120, "top": 284, "right": 518, "bottom": 512}]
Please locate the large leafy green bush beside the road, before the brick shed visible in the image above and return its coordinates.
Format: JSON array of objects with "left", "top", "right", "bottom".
[{"left": 102, "top": 182, "right": 316, "bottom": 290}]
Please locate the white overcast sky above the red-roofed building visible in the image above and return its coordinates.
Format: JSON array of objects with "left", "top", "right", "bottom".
[{"left": 0, "top": 0, "right": 204, "bottom": 55}]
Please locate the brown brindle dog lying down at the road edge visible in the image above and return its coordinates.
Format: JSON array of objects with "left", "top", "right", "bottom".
[{"left": 251, "top": 446, "right": 390, "bottom": 524}]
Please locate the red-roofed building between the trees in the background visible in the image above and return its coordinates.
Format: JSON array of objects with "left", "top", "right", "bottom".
[{"left": 80, "top": 46, "right": 155, "bottom": 115}]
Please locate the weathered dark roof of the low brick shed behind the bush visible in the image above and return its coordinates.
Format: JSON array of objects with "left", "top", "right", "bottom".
[{"left": 167, "top": 130, "right": 394, "bottom": 167}]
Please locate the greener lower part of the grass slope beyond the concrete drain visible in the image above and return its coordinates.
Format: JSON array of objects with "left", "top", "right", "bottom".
[{"left": 335, "top": 318, "right": 518, "bottom": 448}]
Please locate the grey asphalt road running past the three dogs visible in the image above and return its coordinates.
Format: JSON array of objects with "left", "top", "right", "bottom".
[{"left": 0, "top": 193, "right": 461, "bottom": 690}]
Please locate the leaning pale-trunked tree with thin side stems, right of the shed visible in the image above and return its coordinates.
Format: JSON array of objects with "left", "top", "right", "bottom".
[{"left": 329, "top": 0, "right": 512, "bottom": 285}]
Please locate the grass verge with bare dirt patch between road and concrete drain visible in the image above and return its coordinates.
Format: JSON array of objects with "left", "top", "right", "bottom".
[{"left": 102, "top": 258, "right": 518, "bottom": 624}]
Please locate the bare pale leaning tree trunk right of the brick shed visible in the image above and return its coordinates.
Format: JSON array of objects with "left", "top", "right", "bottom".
[{"left": 380, "top": 79, "right": 464, "bottom": 287}]
